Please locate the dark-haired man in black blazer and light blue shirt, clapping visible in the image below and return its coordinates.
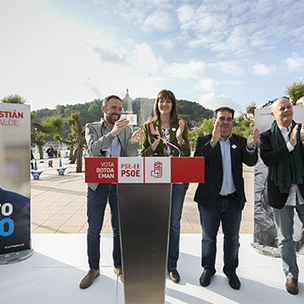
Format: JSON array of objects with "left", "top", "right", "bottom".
[{"left": 194, "top": 107, "right": 259, "bottom": 289}]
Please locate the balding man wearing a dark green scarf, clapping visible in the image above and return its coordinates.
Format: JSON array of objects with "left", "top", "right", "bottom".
[{"left": 260, "top": 97, "right": 304, "bottom": 294}]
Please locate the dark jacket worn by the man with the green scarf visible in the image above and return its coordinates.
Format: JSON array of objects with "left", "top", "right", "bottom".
[{"left": 260, "top": 129, "right": 304, "bottom": 209}]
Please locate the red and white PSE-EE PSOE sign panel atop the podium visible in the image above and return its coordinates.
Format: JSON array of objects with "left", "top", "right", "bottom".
[{"left": 85, "top": 157, "right": 204, "bottom": 184}]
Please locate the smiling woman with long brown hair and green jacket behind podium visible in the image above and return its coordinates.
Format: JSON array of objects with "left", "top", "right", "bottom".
[{"left": 141, "top": 90, "right": 190, "bottom": 283}]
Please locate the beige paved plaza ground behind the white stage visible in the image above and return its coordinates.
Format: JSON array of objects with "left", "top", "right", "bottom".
[{"left": 31, "top": 159, "right": 254, "bottom": 233}]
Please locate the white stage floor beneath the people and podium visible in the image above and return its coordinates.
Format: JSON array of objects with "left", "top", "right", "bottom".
[{"left": 0, "top": 234, "right": 304, "bottom": 304}]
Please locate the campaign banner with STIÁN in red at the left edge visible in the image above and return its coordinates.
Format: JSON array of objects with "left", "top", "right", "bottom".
[{"left": 0, "top": 103, "right": 31, "bottom": 255}]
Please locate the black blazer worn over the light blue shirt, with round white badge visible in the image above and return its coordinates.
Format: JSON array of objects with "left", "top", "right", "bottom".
[{"left": 194, "top": 134, "right": 258, "bottom": 208}]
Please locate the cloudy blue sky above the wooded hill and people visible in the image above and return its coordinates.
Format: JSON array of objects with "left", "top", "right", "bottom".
[{"left": 0, "top": 0, "right": 304, "bottom": 111}]
